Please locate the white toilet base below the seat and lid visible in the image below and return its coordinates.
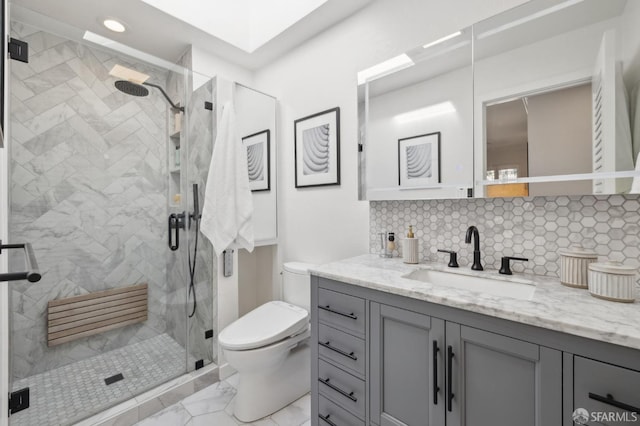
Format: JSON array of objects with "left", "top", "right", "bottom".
[{"left": 233, "top": 342, "right": 311, "bottom": 423}]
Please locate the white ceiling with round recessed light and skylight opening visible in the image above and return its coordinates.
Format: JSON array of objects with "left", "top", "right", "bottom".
[{"left": 11, "top": 0, "right": 373, "bottom": 70}]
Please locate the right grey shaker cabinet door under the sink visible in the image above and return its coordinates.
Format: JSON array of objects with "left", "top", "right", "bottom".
[{"left": 446, "top": 322, "right": 562, "bottom": 426}]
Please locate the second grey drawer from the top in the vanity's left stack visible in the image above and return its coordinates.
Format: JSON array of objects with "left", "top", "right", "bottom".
[{"left": 318, "top": 324, "right": 365, "bottom": 375}]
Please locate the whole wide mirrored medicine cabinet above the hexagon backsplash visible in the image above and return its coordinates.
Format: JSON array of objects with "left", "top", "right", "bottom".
[{"left": 358, "top": 0, "right": 640, "bottom": 200}]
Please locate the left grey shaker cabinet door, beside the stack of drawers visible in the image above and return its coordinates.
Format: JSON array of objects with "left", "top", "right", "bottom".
[{"left": 369, "top": 303, "right": 445, "bottom": 426}]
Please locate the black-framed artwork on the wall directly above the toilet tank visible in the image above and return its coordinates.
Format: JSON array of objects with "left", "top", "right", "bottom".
[{"left": 293, "top": 107, "right": 340, "bottom": 188}]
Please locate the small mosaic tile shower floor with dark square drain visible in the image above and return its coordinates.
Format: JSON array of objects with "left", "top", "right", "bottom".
[{"left": 9, "top": 334, "right": 185, "bottom": 426}]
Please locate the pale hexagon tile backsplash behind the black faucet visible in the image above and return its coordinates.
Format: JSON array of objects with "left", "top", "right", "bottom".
[{"left": 369, "top": 195, "right": 640, "bottom": 282}]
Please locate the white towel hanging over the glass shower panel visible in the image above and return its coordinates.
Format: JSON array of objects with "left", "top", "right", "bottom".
[{"left": 200, "top": 101, "right": 254, "bottom": 256}]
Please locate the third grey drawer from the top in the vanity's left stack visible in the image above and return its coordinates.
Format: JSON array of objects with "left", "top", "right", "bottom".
[{"left": 318, "top": 360, "right": 365, "bottom": 418}]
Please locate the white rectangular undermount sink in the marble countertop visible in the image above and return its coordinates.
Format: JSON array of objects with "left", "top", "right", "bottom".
[{"left": 403, "top": 269, "right": 536, "bottom": 300}]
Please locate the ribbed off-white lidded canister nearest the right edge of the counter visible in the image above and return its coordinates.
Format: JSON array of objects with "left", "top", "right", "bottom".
[{"left": 589, "top": 261, "right": 638, "bottom": 303}]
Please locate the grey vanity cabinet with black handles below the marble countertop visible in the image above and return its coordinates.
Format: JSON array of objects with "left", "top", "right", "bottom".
[{"left": 311, "top": 276, "right": 640, "bottom": 426}]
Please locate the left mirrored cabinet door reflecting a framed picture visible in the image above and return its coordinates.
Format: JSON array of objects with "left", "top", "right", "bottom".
[{"left": 358, "top": 28, "right": 473, "bottom": 200}]
